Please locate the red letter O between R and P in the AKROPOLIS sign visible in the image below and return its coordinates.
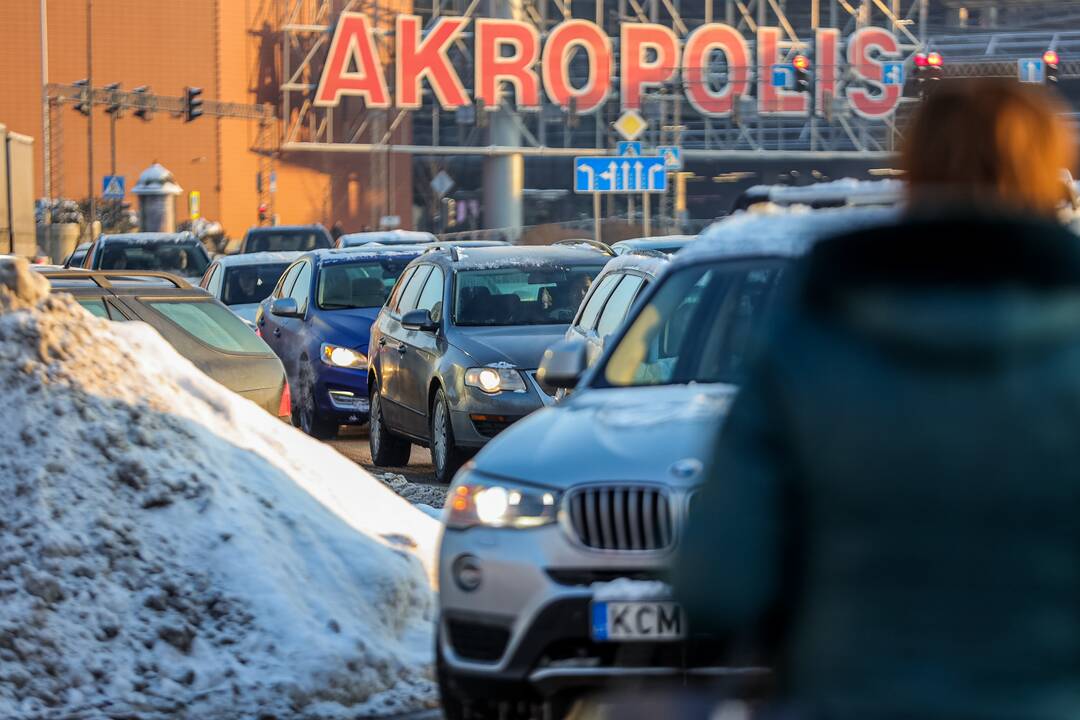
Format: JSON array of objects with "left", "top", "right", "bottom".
[{"left": 541, "top": 21, "right": 611, "bottom": 113}]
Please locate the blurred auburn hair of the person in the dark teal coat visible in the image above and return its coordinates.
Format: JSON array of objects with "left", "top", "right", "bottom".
[{"left": 901, "top": 79, "right": 1076, "bottom": 215}]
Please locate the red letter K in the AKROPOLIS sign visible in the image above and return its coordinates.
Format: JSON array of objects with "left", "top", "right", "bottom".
[{"left": 394, "top": 15, "right": 469, "bottom": 110}]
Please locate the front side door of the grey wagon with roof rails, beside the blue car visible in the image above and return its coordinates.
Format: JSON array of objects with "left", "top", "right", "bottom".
[{"left": 399, "top": 266, "right": 445, "bottom": 437}]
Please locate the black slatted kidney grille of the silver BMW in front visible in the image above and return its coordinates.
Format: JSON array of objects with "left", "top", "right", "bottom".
[{"left": 566, "top": 486, "right": 675, "bottom": 552}]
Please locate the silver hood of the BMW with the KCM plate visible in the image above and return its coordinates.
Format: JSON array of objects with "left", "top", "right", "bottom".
[{"left": 475, "top": 384, "right": 735, "bottom": 488}]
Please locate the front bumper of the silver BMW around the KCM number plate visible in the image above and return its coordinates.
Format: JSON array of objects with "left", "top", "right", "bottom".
[{"left": 438, "top": 525, "right": 766, "bottom": 696}]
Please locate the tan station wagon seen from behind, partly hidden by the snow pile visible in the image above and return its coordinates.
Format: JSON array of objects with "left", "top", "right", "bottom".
[{"left": 41, "top": 270, "right": 289, "bottom": 416}]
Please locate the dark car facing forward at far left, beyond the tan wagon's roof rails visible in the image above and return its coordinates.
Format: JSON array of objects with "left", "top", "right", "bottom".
[{"left": 82, "top": 232, "right": 210, "bottom": 281}]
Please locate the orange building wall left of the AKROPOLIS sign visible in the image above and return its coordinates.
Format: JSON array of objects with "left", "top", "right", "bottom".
[{"left": 0, "top": 0, "right": 413, "bottom": 236}]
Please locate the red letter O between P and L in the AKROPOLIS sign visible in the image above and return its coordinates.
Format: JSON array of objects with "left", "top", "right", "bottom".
[{"left": 683, "top": 23, "right": 750, "bottom": 117}]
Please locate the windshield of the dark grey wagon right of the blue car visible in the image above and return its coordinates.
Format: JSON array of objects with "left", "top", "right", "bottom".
[{"left": 454, "top": 266, "right": 603, "bottom": 326}]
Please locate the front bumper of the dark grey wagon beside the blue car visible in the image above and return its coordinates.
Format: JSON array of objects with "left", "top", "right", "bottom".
[{"left": 450, "top": 372, "right": 555, "bottom": 448}]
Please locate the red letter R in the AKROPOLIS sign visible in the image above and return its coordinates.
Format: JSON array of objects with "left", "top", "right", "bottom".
[{"left": 476, "top": 18, "right": 540, "bottom": 108}]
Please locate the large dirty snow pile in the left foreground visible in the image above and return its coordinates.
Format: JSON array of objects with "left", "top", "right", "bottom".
[{"left": 0, "top": 260, "right": 438, "bottom": 719}]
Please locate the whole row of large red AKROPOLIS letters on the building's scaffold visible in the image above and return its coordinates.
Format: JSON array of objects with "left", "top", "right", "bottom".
[{"left": 314, "top": 13, "right": 902, "bottom": 119}]
